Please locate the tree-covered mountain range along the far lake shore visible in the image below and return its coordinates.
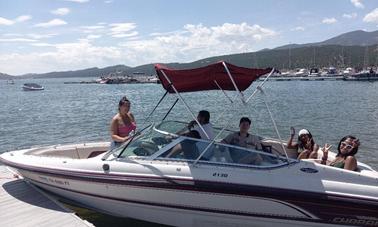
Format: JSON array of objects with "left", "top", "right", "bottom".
[{"left": 0, "top": 30, "right": 378, "bottom": 79}]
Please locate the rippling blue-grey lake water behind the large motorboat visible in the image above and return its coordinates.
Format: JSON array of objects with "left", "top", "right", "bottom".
[{"left": 0, "top": 78, "right": 378, "bottom": 225}]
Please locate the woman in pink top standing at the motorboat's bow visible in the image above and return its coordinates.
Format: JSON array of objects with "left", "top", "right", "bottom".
[{"left": 110, "top": 96, "right": 136, "bottom": 148}]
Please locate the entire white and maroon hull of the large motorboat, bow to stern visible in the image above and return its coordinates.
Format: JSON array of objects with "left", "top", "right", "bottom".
[{"left": 0, "top": 143, "right": 378, "bottom": 226}]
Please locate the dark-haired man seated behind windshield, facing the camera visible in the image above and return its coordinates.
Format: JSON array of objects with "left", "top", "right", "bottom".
[{"left": 222, "top": 117, "right": 262, "bottom": 164}]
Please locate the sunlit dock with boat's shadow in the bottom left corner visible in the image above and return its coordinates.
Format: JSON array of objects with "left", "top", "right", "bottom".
[{"left": 0, "top": 164, "right": 94, "bottom": 227}]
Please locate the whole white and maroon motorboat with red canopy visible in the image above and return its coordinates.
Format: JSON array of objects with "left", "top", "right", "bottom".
[{"left": 0, "top": 62, "right": 378, "bottom": 226}]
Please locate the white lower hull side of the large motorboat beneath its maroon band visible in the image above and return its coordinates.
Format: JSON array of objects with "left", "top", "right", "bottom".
[{"left": 11, "top": 168, "right": 342, "bottom": 226}]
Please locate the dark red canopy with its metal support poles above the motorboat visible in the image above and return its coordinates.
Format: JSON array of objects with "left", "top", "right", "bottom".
[{"left": 141, "top": 61, "right": 289, "bottom": 164}]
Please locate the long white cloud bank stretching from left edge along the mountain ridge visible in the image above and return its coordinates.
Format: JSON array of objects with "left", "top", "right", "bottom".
[{"left": 0, "top": 23, "right": 278, "bottom": 75}]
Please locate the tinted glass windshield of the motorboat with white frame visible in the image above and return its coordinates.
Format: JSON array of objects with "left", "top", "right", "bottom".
[{"left": 113, "top": 121, "right": 295, "bottom": 168}]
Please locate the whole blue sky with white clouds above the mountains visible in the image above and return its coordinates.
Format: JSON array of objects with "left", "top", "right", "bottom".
[{"left": 0, "top": 0, "right": 378, "bottom": 75}]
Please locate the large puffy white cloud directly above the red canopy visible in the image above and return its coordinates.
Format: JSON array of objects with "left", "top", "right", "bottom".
[{"left": 119, "top": 23, "right": 277, "bottom": 65}]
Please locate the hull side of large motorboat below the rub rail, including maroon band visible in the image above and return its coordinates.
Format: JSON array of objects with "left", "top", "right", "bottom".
[{"left": 3, "top": 160, "right": 378, "bottom": 226}]
